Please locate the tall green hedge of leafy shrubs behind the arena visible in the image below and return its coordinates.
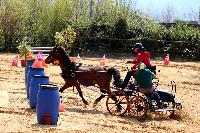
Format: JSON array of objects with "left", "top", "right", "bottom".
[{"left": 0, "top": 0, "right": 200, "bottom": 59}]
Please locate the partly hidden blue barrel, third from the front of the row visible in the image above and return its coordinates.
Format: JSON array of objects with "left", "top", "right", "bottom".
[{"left": 26, "top": 67, "right": 45, "bottom": 98}]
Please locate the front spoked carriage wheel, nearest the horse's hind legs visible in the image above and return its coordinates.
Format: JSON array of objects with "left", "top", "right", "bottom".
[{"left": 106, "top": 90, "right": 128, "bottom": 116}]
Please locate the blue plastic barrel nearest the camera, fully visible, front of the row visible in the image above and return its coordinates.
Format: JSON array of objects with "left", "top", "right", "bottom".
[{"left": 36, "top": 84, "right": 60, "bottom": 125}]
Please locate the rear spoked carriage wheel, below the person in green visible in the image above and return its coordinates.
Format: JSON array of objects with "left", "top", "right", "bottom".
[{"left": 128, "top": 95, "right": 147, "bottom": 117}]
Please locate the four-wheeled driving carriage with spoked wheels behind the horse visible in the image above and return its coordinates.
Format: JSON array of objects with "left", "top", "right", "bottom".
[{"left": 106, "top": 79, "right": 182, "bottom": 117}]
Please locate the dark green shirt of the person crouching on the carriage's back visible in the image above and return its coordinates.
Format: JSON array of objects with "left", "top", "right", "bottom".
[{"left": 134, "top": 69, "right": 153, "bottom": 88}]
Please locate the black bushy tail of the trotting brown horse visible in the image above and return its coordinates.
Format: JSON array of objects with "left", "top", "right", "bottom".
[{"left": 107, "top": 67, "right": 123, "bottom": 88}]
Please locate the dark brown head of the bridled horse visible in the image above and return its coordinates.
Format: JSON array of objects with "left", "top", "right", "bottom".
[{"left": 45, "top": 46, "right": 65, "bottom": 64}]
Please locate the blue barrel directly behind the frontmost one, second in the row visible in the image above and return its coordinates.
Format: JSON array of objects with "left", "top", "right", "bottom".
[{"left": 29, "top": 75, "right": 49, "bottom": 109}]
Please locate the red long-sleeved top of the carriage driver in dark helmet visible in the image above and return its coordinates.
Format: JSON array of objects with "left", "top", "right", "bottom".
[{"left": 131, "top": 51, "right": 151, "bottom": 70}]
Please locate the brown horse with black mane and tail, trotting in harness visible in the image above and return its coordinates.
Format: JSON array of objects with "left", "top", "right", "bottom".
[{"left": 45, "top": 46, "right": 121, "bottom": 106}]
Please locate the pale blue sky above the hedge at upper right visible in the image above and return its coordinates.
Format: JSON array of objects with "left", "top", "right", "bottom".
[{"left": 134, "top": 0, "right": 200, "bottom": 21}]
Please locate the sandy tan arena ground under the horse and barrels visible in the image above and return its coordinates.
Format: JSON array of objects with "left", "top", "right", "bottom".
[{"left": 0, "top": 54, "right": 200, "bottom": 133}]
